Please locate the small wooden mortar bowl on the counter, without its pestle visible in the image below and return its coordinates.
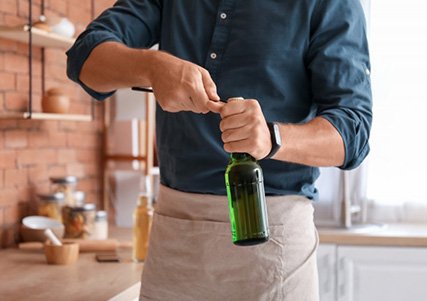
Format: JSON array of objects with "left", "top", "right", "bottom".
[{"left": 44, "top": 242, "right": 79, "bottom": 265}]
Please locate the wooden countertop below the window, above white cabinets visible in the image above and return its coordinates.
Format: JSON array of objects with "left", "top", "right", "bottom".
[{"left": 317, "top": 224, "right": 427, "bottom": 247}]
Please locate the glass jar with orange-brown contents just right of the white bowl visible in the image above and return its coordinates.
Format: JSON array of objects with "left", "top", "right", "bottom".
[{"left": 62, "top": 203, "right": 96, "bottom": 239}]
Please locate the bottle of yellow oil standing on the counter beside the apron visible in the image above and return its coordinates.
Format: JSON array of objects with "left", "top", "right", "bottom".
[{"left": 132, "top": 176, "right": 154, "bottom": 262}]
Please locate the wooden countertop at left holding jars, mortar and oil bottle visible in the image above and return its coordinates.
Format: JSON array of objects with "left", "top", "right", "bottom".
[{"left": 0, "top": 229, "right": 143, "bottom": 301}]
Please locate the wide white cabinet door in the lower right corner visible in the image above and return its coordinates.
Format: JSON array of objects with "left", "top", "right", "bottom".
[{"left": 337, "top": 246, "right": 427, "bottom": 301}]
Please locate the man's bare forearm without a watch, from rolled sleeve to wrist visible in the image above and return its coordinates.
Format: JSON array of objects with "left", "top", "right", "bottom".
[{"left": 80, "top": 42, "right": 153, "bottom": 92}]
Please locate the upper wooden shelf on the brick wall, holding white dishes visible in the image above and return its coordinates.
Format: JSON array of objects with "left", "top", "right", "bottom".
[{"left": 0, "top": 25, "right": 75, "bottom": 49}]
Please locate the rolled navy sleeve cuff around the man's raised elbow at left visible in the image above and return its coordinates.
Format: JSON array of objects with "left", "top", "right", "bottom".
[{"left": 66, "top": 31, "right": 122, "bottom": 100}]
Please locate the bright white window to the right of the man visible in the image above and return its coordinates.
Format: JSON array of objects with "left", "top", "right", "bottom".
[{"left": 367, "top": 0, "right": 427, "bottom": 205}]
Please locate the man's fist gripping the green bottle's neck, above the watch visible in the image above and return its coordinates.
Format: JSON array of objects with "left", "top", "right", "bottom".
[{"left": 207, "top": 99, "right": 271, "bottom": 160}]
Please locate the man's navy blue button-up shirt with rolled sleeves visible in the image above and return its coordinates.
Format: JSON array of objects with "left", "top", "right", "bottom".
[{"left": 67, "top": 0, "right": 372, "bottom": 198}]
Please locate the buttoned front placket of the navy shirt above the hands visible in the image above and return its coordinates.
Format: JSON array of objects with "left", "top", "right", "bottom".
[{"left": 205, "top": 0, "right": 236, "bottom": 80}]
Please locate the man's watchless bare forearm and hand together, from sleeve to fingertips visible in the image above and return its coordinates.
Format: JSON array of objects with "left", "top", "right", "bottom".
[{"left": 79, "top": 41, "right": 219, "bottom": 113}]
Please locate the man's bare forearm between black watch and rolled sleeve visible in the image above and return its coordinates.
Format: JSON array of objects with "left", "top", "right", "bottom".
[{"left": 273, "top": 117, "right": 345, "bottom": 166}]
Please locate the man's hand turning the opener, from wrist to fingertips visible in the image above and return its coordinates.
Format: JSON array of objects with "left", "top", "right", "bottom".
[{"left": 144, "top": 50, "right": 220, "bottom": 114}]
